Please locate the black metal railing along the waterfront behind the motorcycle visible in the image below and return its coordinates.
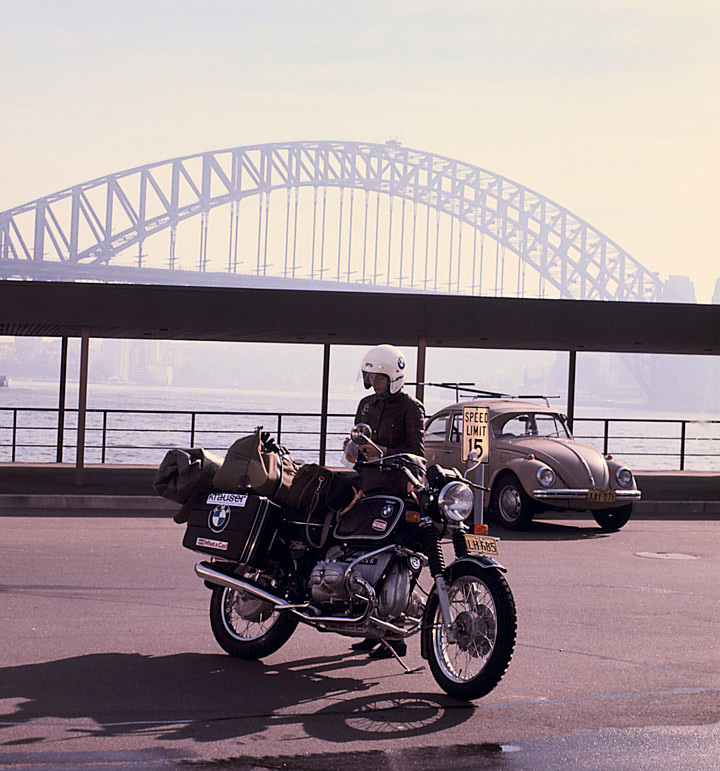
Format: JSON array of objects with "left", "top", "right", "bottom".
[{"left": 0, "top": 407, "right": 720, "bottom": 470}]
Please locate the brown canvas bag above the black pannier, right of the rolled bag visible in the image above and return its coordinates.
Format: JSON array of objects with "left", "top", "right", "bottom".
[{"left": 213, "top": 426, "right": 295, "bottom": 498}]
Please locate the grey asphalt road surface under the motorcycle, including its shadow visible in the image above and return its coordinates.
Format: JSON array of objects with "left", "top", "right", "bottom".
[{"left": 0, "top": 516, "right": 720, "bottom": 771}]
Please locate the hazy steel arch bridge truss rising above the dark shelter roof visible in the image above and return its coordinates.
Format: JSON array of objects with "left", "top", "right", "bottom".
[{"left": 0, "top": 142, "right": 662, "bottom": 301}]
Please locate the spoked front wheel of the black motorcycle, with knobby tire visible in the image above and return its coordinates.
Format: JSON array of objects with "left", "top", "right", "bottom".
[{"left": 422, "top": 562, "right": 517, "bottom": 701}]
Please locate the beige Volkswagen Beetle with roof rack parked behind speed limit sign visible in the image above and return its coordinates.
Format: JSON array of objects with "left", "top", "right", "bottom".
[{"left": 425, "top": 399, "right": 641, "bottom": 530}]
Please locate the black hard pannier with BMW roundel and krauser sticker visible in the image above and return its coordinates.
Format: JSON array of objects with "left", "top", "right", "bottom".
[{"left": 183, "top": 491, "right": 281, "bottom": 568}]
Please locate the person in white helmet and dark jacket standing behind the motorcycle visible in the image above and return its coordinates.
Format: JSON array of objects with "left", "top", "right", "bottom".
[{"left": 351, "top": 344, "right": 425, "bottom": 658}]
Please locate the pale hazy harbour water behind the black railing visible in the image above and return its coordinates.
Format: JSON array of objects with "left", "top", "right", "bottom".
[{"left": 0, "top": 380, "right": 720, "bottom": 471}]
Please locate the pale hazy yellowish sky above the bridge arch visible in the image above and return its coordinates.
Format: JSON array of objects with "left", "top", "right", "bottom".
[{"left": 0, "top": 0, "right": 720, "bottom": 302}]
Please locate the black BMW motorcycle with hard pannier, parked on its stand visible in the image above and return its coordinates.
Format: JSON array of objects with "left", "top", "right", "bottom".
[{"left": 183, "top": 425, "right": 517, "bottom": 700}]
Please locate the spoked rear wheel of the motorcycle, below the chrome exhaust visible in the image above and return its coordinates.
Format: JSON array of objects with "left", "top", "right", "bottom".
[{"left": 210, "top": 586, "right": 298, "bottom": 659}]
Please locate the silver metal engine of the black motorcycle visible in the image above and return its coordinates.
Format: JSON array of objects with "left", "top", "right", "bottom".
[{"left": 309, "top": 546, "right": 410, "bottom": 618}]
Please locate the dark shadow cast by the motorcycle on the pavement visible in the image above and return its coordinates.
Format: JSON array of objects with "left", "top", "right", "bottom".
[{"left": 0, "top": 653, "right": 474, "bottom": 746}]
